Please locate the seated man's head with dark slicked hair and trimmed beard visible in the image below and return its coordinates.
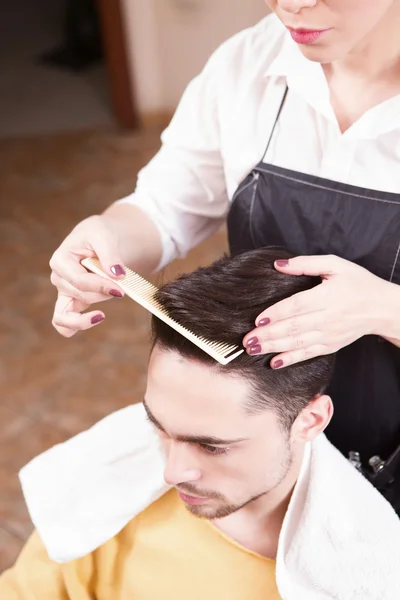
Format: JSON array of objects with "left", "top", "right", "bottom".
[{"left": 145, "top": 249, "right": 333, "bottom": 518}]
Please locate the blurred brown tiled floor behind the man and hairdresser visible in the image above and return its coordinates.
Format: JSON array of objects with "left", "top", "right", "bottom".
[{"left": 0, "top": 125, "right": 226, "bottom": 572}]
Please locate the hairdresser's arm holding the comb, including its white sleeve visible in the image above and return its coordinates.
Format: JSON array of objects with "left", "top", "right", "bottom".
[{"left": 50, "top": 43, "right": 228, "bottom": 337}]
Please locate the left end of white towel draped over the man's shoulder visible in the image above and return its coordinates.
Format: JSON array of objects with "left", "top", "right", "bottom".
[{"left": 19, "top": 403, "right": 168, "bottom": 563}]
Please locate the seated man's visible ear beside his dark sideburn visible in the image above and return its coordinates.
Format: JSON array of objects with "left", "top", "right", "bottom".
[{"left": 291, "top": 394, "right": 333, "bottom": 442}]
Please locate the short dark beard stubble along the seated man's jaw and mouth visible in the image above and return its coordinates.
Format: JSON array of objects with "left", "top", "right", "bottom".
[{"left": 177, "top": 452, "right": 293, "bottom": 521}]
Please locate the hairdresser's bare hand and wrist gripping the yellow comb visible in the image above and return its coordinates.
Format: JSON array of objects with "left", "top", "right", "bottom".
[{"left": 50, "top": 203, "right": 162, "bottom": 337}]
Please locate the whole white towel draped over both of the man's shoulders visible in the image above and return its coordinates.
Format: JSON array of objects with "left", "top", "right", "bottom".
[{"left": 20, "top": 404, "right": 400, "bottom": 600}]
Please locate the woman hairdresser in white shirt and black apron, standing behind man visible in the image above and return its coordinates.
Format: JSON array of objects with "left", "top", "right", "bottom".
[{"left": 50, "top": 0, "right": 400, "bottom": 511}]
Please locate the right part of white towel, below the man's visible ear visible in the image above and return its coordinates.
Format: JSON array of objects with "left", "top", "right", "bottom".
[{"left": 277, "top": 436, "right": 400, "bottom": 600}]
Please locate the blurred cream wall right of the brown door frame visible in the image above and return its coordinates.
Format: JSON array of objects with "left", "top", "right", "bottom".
[{"left": 123, "top": 0, "right": 267, "bottom": 114}]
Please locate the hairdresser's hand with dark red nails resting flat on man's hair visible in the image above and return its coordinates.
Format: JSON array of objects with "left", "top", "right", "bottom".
[{"left": 243, "top": 256, "right": 392, "bottom": 369}]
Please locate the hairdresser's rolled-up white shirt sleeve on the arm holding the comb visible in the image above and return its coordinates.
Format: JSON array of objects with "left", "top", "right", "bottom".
[{"left": 120, "top": 45, "right": 229, "bottom": 268}]
